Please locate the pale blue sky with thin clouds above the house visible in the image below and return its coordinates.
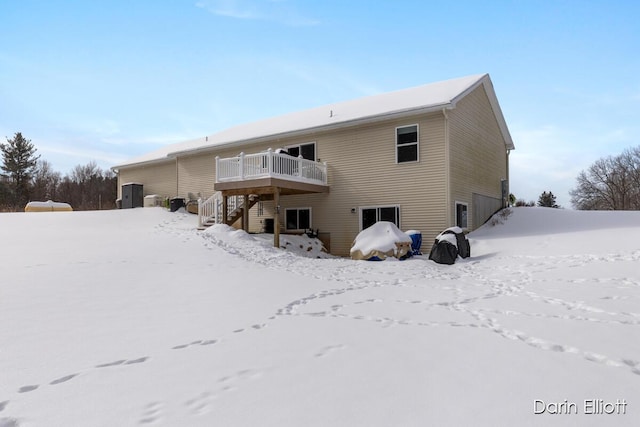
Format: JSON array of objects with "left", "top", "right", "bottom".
[{"left": 0, "top": 0, "right": 640, "bottom": 207}]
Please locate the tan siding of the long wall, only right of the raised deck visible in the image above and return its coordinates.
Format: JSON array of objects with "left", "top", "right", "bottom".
[{"left": 262, "top": 113, "right": 446, "bottom": 255}]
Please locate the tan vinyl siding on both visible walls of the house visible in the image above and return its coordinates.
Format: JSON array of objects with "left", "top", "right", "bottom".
[{"left": 120, "top": 105, "right": 507, "bottom": 255}]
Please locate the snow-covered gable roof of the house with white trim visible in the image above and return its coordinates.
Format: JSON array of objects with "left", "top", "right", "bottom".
[{"left": 112, "top": 74, "right": 514, "bottom": 170}]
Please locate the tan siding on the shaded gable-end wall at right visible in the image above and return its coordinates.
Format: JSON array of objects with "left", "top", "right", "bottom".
[{"left": 449, "top": 86, "right": 507, "bottom": 229}]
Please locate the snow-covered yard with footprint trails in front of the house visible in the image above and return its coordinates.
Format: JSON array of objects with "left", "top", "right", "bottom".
[{"left": 0, "top": 208, "right": 640, "bottom": 427}]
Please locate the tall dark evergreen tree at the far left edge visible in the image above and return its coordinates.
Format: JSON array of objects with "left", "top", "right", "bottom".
[{"left": 0, "top": 132, "right": 40, "bottom": 209}]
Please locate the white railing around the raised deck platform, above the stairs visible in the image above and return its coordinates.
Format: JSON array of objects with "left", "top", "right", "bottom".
[{"left": 216, "top": 149, "right": 327, "bottom": 185}]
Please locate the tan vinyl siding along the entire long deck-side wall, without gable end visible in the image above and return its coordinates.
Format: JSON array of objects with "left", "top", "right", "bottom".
[{"left": 122, "top": 112, "right": 448, "bottom": 255}]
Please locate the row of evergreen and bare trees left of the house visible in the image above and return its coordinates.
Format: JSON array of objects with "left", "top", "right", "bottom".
[{"left": 0, "top": 132, "right": 118, "bottom": 212}]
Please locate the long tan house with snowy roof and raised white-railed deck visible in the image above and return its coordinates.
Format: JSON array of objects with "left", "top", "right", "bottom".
[{"left": 112, "top": 74, "right": 514, "bottom": 255}]
